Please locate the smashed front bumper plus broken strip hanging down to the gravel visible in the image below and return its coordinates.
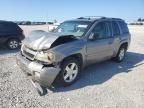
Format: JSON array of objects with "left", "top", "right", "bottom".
[{"left": 16, "top": 50, "right": 60, "bottom": 95}]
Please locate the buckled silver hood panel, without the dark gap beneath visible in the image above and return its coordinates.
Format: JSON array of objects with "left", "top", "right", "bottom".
[{"left": 23, "top": 30, "right": 62, "bottom": 50}]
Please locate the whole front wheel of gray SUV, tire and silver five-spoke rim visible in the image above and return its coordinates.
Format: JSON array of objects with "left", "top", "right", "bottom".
[{"left": 56, "top": 57, "right": 81, "bottom": 86}]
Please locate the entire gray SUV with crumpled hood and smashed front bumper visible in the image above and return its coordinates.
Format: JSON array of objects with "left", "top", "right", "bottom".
[{"left": 17, "top": 17, "right": 130, "bottom": 87}]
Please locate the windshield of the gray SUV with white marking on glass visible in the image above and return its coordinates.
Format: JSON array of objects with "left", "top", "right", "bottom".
[{"left": 53, "top": 21, "right": 90, "bottom": 37}]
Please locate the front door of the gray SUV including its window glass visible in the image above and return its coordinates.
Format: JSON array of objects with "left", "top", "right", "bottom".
[{"left": 87, "top": 21, "right": 114, "bottom": 63}]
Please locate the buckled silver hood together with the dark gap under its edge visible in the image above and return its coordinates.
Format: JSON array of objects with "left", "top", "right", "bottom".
[{"left": 23, "top": 30, "right": 77, "bottom": 51}]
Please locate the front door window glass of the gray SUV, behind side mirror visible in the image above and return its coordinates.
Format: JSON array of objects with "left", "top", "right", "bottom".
[{"left": 92, "top": 22, "right": 108, "bottom": 39}]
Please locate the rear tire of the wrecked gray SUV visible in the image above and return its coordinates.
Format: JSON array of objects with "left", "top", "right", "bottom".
[{"left": 114, "top": 45, "right": 127, "bottom": 62}]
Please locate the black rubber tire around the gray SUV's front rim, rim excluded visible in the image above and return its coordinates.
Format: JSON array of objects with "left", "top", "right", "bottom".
[{"left": 54, "top": 57, "right": 81, "bottom": 87}]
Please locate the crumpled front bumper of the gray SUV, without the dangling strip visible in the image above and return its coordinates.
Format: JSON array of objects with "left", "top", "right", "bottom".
[{"left": 16, "top": 54, "right": 60, "bottom": 87}]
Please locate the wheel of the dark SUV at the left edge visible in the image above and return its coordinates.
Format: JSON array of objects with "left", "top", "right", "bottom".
[{"left": 7, "top": 39, "right": 20, "bottom": 50}]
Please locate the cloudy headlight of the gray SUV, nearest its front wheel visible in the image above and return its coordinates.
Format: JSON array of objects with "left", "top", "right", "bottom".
[{"left": 36, "top": 52, "right": 55, "bottom": 63}]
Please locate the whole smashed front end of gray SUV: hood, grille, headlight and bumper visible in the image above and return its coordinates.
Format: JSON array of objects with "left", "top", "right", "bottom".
[{"left": 16, "top": 31, "right": 76, "bottom": 94}]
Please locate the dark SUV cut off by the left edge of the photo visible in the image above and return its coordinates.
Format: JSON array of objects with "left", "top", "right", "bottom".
[{"left": 0, "top": 21, "right": 24, "bottom": 49}]
